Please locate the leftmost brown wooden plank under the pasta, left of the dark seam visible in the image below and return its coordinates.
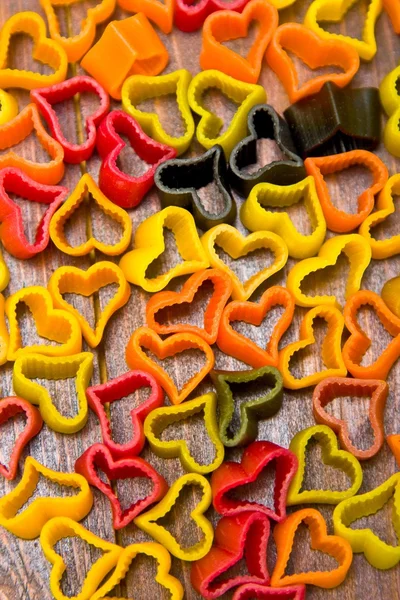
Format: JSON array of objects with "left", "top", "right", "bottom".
[{"left": 0, "top": 2, "right": 115, "bottom": 600}]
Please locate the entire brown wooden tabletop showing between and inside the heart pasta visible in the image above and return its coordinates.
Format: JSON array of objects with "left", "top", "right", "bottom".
[{"left": 0, "top": 0, "right": 400, "bottom": 600}]
